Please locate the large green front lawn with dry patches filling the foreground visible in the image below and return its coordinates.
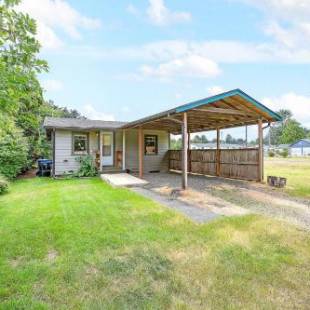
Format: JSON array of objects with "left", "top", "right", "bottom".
[{"left": 0, "top": 178, "right": 310, "bottom": 309}]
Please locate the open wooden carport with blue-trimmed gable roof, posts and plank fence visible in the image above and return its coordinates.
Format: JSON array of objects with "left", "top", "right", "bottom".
[{"left": 124, "top": 89, "right": 281, "bottom": 189}]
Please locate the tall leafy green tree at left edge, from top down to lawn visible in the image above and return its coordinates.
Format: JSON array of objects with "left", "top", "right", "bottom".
[{"left": 0, "top": 0, "right": 48, "bottom": 177}]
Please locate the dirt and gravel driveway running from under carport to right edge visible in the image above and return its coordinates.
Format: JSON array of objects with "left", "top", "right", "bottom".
[{"left": 145, "top": 173, "right": 310, "bottom": 229}]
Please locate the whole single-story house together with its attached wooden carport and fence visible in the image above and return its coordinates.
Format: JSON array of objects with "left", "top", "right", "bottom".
[{"left": 43, "top": 89, "right": 281, "bottom": 188}]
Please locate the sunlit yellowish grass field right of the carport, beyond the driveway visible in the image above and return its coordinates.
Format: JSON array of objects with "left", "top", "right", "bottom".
[{"left": 265, "top": 157, "right": 310, "bottom": 199}]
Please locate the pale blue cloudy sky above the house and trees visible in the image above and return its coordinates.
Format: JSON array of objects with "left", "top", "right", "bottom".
[{"left": 19, "top": 0, "right": 310, "bottom": 136}]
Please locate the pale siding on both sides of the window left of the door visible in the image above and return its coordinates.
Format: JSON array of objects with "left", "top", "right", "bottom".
[{"left": 55, "top": 129, "right": 98, "bottom": 175}]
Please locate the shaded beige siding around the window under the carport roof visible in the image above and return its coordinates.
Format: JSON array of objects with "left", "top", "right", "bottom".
[{"left": 126, "top": 129, "right": 169, "bottom": 172}]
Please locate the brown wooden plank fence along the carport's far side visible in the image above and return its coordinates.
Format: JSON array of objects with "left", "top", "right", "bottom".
[{"left": 169, "top": 148, "right": 259, "bottom": 181}]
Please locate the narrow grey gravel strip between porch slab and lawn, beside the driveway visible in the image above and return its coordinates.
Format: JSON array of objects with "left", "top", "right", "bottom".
[{"left": 130, "top": 187, "right": 220, "bottom": 223}]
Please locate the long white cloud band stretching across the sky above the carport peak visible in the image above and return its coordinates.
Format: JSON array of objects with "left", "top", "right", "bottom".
[{"left": 70, "top": 40, "right": 310, "bottom": 81}]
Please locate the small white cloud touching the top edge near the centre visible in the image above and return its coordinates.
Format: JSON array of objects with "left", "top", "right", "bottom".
[{"left": 147, "top": 0, "right": 192, "bottom": 26}]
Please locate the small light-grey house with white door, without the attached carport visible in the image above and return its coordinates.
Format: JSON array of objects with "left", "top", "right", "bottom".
[{"left": 44, "top": 117, "right": 169, "bottom": 176}]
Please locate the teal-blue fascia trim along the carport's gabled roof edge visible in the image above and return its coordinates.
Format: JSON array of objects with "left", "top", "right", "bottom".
[{"left": 176, "top": 88, "right": 282, "bottom": 121}]
